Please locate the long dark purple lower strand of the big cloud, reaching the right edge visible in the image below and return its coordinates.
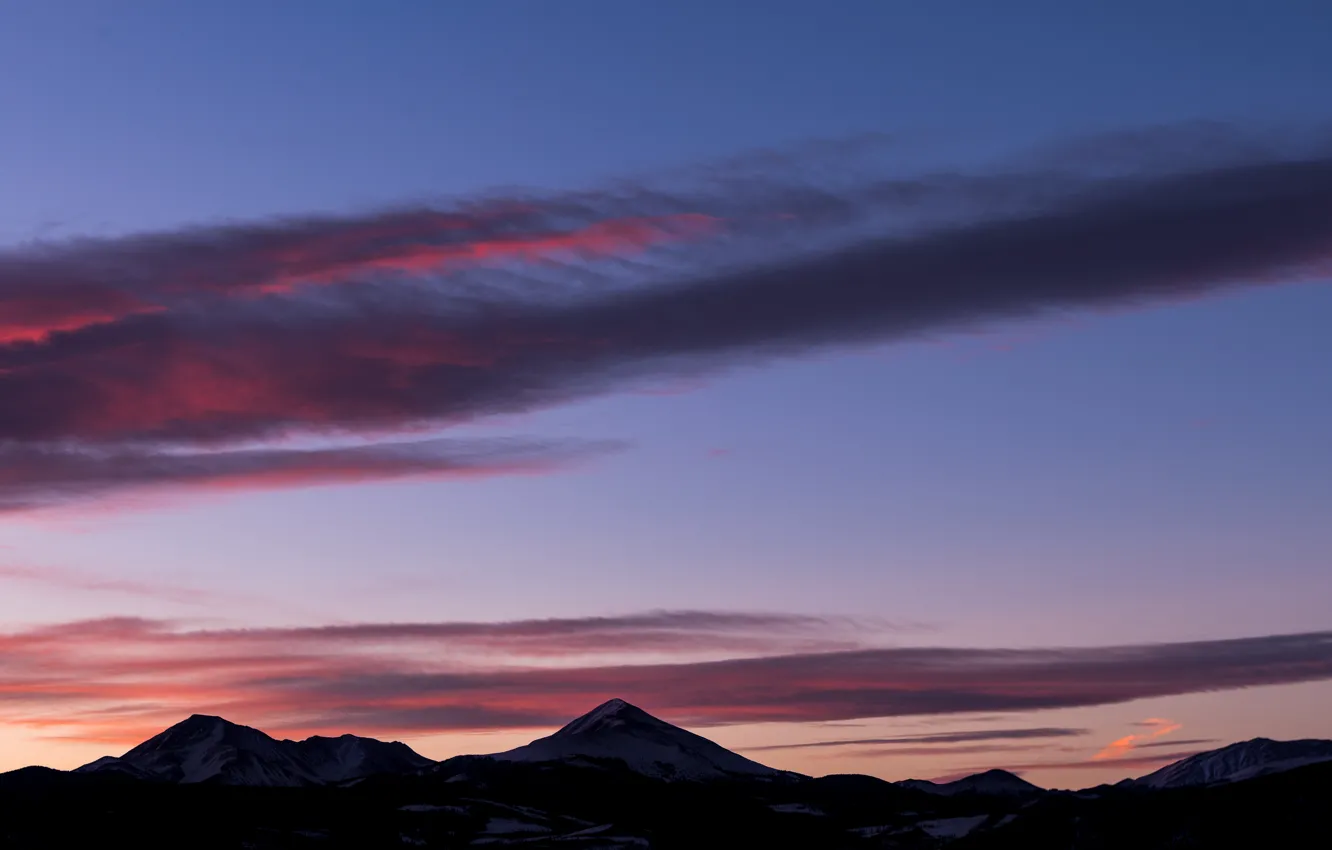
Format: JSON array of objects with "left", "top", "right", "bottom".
[{"left": 10, "top": 149, "right": 1332, "bottom": 440}]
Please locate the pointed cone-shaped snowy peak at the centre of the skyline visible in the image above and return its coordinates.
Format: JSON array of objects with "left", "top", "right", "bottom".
[{"left": 492, "top": 699, "right": 789, "bottom": 779}]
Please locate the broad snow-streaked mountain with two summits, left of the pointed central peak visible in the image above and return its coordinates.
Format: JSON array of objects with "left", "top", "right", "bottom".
[{"left": 77, "top": 714, "right": 434, "bottom": 787}]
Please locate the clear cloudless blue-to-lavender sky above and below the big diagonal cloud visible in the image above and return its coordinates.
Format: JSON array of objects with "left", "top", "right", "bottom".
[{"left": 0, "top": 0, "right": 1332, "bottom": 788}]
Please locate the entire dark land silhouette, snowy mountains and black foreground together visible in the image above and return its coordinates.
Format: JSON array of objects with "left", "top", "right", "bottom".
[{"left": 0, "top": 699, "right": 1332, "bottom": 850}]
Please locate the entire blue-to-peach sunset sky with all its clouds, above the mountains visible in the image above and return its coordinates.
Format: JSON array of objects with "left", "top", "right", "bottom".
[{"left": 0, "top": 0, "right": 1332, "bottom": 787}]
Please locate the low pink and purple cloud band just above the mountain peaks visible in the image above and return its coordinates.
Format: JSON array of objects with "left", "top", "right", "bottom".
[{"left": 0, "top": 612, "right": 1332, "bottom": 761}]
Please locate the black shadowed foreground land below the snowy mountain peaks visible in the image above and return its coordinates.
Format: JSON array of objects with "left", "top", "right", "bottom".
[{"left": 0, "top": 757, "right": 1332, "bottom": 850}]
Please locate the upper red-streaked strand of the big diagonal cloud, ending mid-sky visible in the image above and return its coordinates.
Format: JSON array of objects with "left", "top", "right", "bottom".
[{"left": 0, "top": 211, "right": 721, "bottom": 344}]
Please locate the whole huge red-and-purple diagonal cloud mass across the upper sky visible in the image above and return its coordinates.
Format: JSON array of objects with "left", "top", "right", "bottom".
[{"left": 0, "top": 131, "right": 1332, "bottom": 506}]
